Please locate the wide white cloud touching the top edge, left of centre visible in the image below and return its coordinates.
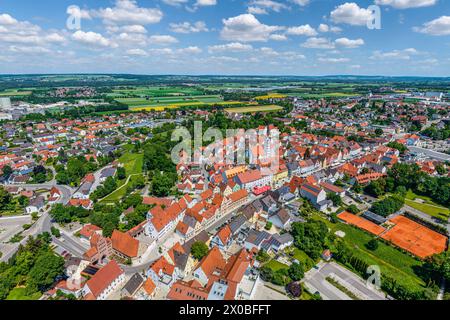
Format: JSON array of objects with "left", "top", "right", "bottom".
[{"left": 92, "top": 0, "right": 163, "bottom": 25}]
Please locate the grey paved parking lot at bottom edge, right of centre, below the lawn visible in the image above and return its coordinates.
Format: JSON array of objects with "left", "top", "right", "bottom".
[{"left": 303, "top": 262, "right": 386, "bottom": 300}]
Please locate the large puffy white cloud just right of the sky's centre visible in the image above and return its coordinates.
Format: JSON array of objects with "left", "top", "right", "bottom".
[{"left": 220, "top": 14, "right": 283, "bottom": 42}]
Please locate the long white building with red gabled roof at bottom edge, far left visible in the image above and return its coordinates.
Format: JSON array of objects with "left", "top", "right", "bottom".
[{"left": 83, "top": 260, "right": 125, "bottom": 300}]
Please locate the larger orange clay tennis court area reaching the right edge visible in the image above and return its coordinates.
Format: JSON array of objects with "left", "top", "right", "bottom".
[{"left": 381, "top": 216, "right": 447, "bottom": 259}]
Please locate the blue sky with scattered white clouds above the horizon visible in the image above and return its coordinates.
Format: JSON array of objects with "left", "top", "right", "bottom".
[{"left": 0, "top": 0, "right": 450, "bottom": 76}]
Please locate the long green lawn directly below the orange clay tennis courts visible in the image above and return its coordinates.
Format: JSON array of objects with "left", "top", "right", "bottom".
[{"left": 314, "top": 216, "right": 425, "bottom": 290}]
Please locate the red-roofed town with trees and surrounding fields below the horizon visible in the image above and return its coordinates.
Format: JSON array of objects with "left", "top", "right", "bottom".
[{"left": 0, "top": 76, "right": 450, "bottom": 301}]
